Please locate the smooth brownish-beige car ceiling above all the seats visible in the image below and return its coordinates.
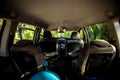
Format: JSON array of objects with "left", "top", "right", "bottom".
[{"left": 0, "top": 0, "right": 120, "bottom": 29}]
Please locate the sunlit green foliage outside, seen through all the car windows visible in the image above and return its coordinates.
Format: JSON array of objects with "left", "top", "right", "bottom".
[{"left": 14, "top": 20, "right": 109, "bottom": 43}]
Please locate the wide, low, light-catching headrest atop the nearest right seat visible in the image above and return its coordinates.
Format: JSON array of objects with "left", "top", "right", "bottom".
[{"left": 91, "top": 39, "right": 110, "bottom": 47}]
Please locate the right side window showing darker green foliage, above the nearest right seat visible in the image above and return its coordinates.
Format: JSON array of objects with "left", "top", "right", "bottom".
[{"left": 87, "top": 22, "right": 109, "bottom": 41}]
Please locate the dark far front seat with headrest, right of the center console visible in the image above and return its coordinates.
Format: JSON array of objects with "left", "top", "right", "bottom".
[{"left": 67, "top": 32, "right": 84, "bottom": 56}]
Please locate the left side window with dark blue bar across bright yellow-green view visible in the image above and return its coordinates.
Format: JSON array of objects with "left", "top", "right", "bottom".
[{"left": 14, "top": 23, "right": 35, "bottom": 43}]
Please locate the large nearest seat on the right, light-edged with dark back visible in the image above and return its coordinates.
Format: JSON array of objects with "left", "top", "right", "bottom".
[{"left": 77, "top": 40, "right": 116, "bottom": 76}]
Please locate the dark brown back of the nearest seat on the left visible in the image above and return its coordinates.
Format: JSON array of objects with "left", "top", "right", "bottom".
[{"left": 10, "top": 44, "right": 45, "bottom": 73}]
